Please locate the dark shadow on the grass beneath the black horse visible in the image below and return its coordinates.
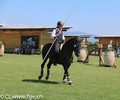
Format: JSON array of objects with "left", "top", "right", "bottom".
[{"left": 22, "top": 79, "right": 60, "bottom": 84}]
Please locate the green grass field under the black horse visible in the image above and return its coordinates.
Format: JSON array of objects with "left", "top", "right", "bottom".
[{"left": 0, "top": 54, "right": 120, "bottom": 100}]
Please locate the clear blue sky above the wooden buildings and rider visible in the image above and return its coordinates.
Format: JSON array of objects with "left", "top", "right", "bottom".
[{"left": 0, "top": 0, "right": 120, "bottom": 35}]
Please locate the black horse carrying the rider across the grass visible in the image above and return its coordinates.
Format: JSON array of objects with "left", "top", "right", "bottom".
[{"left": 38, "top": 38, "right": 81, "bottom": 85}]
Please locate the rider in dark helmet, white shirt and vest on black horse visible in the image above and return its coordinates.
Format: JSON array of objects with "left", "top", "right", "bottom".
[{"left": 51, "top": 21, "right": 65, "bottom": 65}]
